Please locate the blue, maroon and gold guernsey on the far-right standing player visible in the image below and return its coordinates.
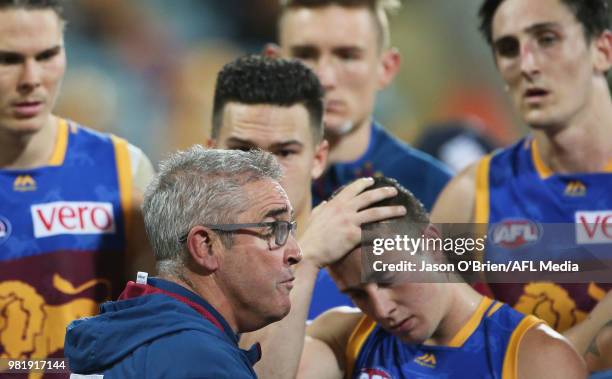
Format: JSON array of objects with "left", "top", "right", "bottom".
[{"left": 475, "top": 137, "right": 612, "bottom": 332}]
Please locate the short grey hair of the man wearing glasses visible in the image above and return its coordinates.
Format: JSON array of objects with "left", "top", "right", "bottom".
[{"left": 142, "top": 145, "right": 282, "bottom": 275}]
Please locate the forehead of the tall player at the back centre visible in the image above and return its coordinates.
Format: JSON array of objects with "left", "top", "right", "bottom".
[{"left": 279, "top": 5, "right": 378, "bottom": 48}]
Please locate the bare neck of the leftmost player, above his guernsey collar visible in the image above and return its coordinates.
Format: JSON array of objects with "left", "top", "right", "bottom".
[{"left": 0, "top": 115, "right": 58, "bottom": 169}]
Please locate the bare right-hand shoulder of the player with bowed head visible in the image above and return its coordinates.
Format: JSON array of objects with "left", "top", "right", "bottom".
[{"left": 518, "top": 324, "right": 587, "bottom": 379}]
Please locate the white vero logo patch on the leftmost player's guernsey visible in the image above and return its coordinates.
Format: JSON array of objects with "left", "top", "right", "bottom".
[{"left": 30, "top": 201, "right": 115, "bottom": 238}]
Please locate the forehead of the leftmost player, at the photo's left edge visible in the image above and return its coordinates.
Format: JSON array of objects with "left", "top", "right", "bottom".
[{"left": 0, "top": 8, "right": 64, "bottom": 54}]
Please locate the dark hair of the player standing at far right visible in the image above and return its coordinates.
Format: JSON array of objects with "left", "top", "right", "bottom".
[{"left": 478, "top": 0, "right": 610, "bottom": 45}]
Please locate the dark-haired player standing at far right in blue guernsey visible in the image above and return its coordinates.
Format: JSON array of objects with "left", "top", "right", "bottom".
[{"left": 432, "top": 0, "right": 612, "bottom": 372}]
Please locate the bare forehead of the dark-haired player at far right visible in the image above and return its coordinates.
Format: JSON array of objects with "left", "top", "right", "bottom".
[{"left": 492, "top": 0, "right": 578, "bottom": 41}]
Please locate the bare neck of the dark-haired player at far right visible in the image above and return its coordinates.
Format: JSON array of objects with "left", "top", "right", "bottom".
[{"left": 534, "top": 91, "right": 612, "bottom": 173}]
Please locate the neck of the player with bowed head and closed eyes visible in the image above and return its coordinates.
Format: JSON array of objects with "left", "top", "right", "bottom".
[{"left": 426, "top": 283, "right": 483, "bottom": 346}]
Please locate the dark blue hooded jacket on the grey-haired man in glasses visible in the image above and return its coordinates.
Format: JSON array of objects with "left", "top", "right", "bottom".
[{"left": 65, "top": 278, "right": 259, "bottom": 379}]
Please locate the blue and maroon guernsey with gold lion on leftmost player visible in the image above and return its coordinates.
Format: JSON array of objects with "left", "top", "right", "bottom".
[{"left": 0, "top": 119, "right": 132, "bottom": 377}]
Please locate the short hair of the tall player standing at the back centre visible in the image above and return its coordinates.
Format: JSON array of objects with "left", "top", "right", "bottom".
[{"left": 279, "top": 0, "right": 401, "bottom": 47}]
